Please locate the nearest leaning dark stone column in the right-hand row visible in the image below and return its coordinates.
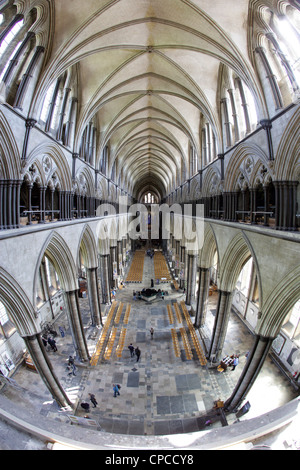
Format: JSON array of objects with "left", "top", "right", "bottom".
[{"left": 225, "top": 335, "right": 274, "bottom": 411}]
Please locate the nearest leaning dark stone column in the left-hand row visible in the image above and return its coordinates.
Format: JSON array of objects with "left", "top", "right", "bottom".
[{"left": 23, "top": 335, "right": 72, "bottom": 408}]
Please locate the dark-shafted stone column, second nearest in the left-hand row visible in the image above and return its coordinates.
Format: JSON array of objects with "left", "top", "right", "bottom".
[{"left": 66, "top": 290, "right": 90, "bottom": 361}]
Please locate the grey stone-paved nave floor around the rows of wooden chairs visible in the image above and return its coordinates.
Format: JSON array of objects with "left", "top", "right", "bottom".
[{"left": 1, "top": 250, "right": 297, "bottom": 448}]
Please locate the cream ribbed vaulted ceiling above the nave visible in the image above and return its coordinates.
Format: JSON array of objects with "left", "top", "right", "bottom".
[{"left": 44, "top": 0, "right": 257, "bottom": 200}]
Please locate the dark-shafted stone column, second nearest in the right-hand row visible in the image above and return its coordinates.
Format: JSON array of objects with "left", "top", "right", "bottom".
[{"left": 209, "top": 290, "right": 232, "bottom": 361}]
